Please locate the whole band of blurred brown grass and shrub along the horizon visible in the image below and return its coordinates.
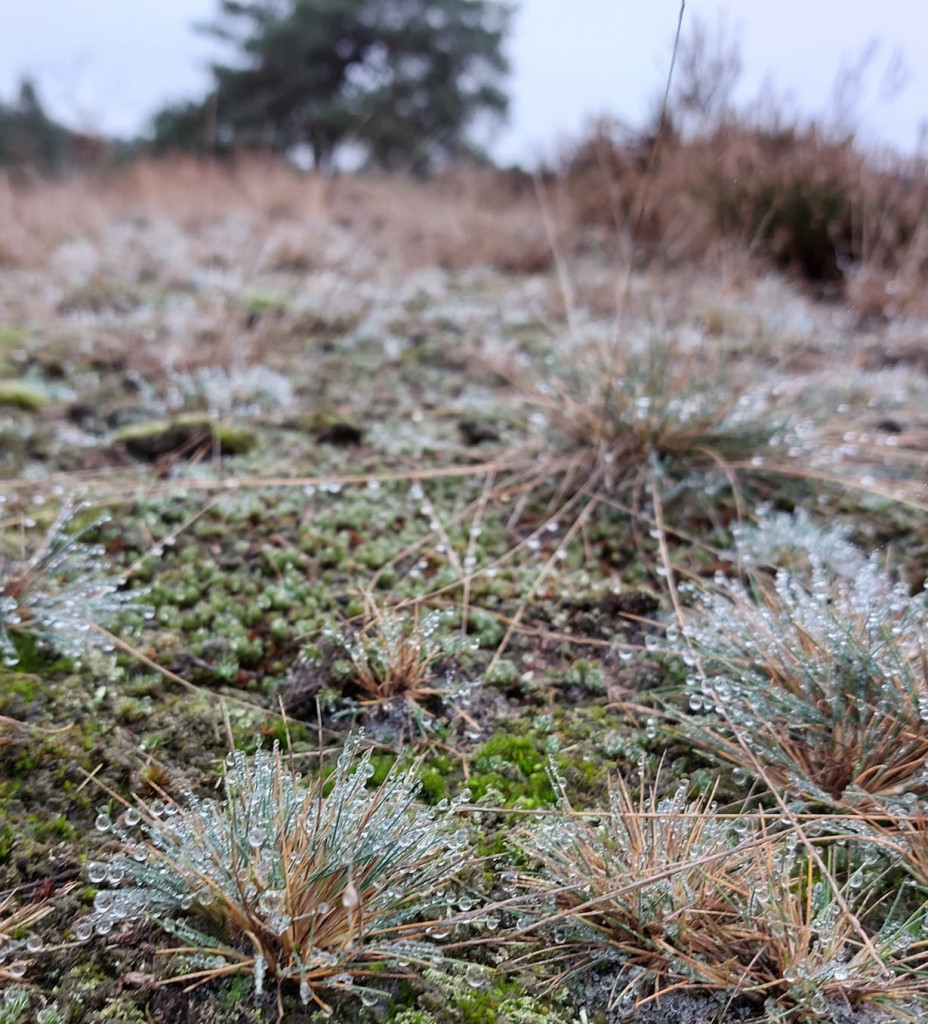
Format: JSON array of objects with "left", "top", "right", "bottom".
[{"left": 0, "top": 120, "right": 928, "bottom": 307}]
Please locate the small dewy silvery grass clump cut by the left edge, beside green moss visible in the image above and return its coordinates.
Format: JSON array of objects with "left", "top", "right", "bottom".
[{"left": 0, "top": 504, "right": 151, "bottom": 666}]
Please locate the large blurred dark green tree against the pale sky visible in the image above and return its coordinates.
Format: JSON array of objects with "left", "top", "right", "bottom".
[{"left": 155, "top": 0, "right": 510, "bottom": 170}]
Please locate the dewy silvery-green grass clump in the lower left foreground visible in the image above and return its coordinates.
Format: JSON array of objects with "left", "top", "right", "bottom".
[{"left": 75, "top": 737, "right": 477, "bottom": 1009}]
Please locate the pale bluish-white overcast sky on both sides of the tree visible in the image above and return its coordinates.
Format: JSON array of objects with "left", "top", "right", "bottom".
[{"left": 0, "top": 0, "right": 928, "bottom": 161}]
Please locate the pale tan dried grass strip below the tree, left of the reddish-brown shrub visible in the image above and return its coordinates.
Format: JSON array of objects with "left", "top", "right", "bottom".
[{"left": 0, "top": 157, "right": 552, "bottom": 273}]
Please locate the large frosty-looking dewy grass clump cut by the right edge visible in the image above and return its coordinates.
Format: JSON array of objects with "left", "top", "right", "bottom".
[{"left": 680, "top": 554, "right": 928, "bottom": 808}]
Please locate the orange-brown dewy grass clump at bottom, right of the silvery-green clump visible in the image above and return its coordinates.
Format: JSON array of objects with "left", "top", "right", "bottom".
[{"left": 510, "top": 778, "right": 748, "bottom": 1013}]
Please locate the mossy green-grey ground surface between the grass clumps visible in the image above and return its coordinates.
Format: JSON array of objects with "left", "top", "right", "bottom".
[{"left": 0, "top": 172, "right": 928, "bottom": 1022}]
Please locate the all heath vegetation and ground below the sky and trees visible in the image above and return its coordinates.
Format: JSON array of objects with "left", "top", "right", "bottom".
[{"left": 0, "top": 70, "right": 928, "bottom": 1024}]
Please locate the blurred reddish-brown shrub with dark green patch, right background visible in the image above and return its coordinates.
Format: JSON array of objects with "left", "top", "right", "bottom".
[{"left": 563, "top": 114, "right": 928, "bottom": 315}]
